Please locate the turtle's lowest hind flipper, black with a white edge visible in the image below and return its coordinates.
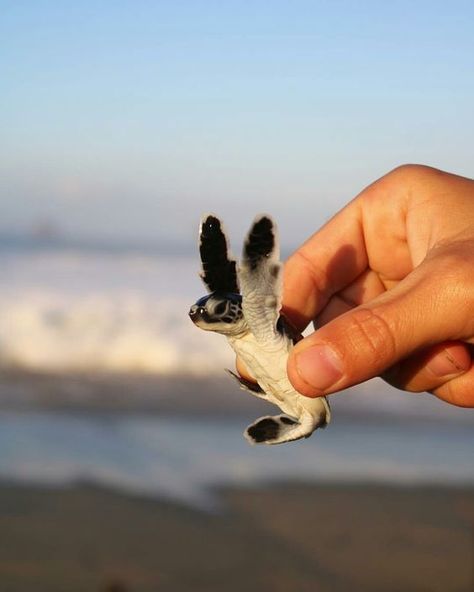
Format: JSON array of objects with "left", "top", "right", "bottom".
[{"left": 244, "top": 413, "right": 326, "bottom": 444}]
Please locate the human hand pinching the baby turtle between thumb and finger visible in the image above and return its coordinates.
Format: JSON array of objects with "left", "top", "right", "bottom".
[{"left": 238, "top": 165, "right": 474, "bottom": 407}]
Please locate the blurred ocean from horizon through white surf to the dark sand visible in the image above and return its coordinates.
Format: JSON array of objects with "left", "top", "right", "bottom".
[{"left": 0, "top": 241, "right": 474, "bottom": 505}]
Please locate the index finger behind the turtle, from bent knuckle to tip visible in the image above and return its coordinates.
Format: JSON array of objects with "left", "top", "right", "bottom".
[{"left": 283, "top": 169, "right": 412, "bottom": 331}]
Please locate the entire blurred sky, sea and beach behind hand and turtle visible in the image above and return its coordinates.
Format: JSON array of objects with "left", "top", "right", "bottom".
[{"left": 0, "top": 0, "right": 474, "bottom": 592}]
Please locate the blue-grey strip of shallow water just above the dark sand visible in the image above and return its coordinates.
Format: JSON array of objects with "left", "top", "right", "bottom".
[{"left": 0, "top": 412, "right": 474, "bottom": 505}]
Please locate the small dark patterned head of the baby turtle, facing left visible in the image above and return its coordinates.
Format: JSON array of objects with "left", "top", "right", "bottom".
[{"left": 189, "top": 292, "right": 248, "bottom": 335}]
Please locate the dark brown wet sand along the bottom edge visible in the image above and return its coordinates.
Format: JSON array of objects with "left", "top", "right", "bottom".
[{"left": 0, "top": 483, "right": 474, "bottom": 592}]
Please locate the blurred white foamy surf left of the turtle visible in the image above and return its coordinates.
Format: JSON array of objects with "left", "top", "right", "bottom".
[{"left": 0, "top": 252, "right": 233, "bottom": 374}]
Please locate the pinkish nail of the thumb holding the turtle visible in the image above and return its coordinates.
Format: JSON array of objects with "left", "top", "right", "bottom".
[{"left": 296, "top": 345, "right": 343, "bottom": 391}]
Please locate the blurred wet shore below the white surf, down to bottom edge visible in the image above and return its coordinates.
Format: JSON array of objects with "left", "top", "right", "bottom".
[{"left": 0, "top": 372, "right": 474, "bottom": 592}]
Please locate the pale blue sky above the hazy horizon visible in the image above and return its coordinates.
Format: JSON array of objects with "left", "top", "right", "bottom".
[{"left": 0, "top": 0, "right": 474, "bottom": 243}]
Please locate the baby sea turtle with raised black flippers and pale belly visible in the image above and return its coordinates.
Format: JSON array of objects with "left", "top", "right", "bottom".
[{"left": 189, "top": 215, "right": 331, "bottom": 444}]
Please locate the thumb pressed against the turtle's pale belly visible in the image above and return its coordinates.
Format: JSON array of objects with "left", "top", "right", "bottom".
[{"left": 288, "top": 251, "right": 474, "bottom": 397}]
